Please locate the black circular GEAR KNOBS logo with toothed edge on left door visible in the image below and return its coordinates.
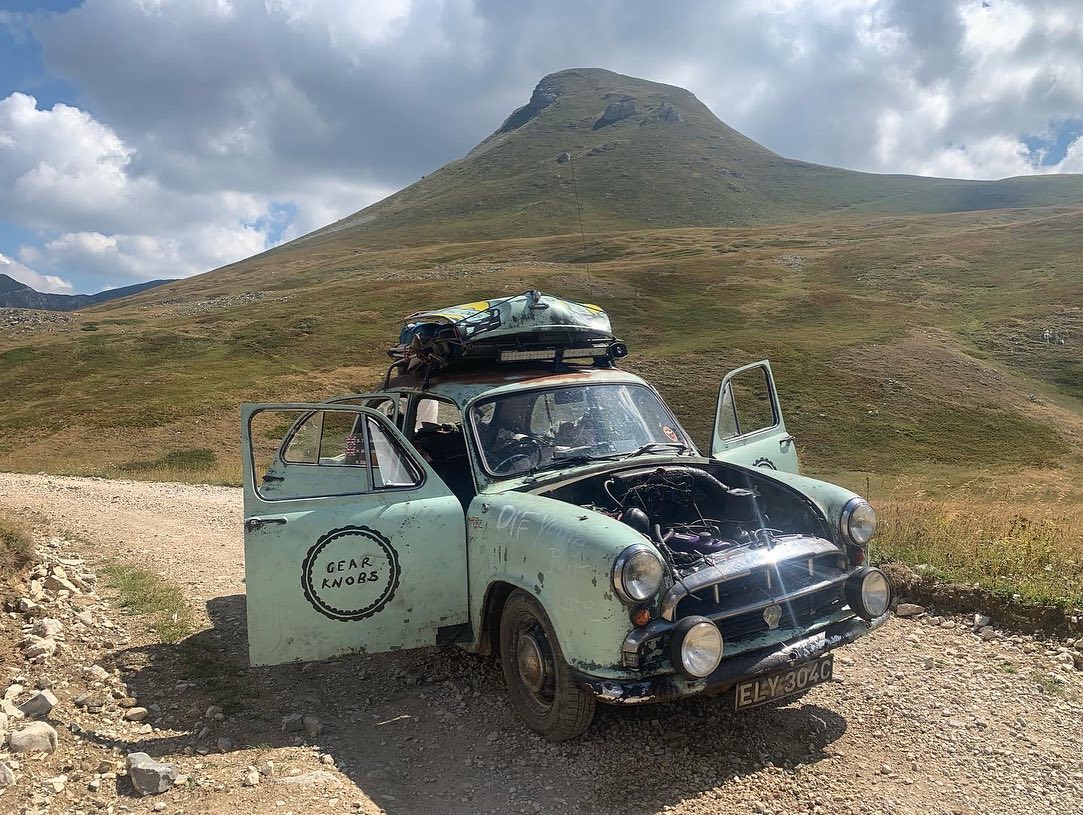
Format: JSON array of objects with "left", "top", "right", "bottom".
[{"left": 301, "top": 526, "right": 399, "bottom": 620}]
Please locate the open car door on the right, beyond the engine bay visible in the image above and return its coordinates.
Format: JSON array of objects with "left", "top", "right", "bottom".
[{"left": 710, "top": 359, "right": 798, "bottom": 473}]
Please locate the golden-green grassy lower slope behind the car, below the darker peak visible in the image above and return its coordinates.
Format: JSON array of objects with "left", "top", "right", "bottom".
[{"left": 0, "top": 211, "right": 1083, "bottom": 489}]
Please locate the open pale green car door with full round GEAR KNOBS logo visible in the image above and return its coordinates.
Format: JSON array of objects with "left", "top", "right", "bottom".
[{"left": 242, "top": 404, "right": 469, "bottom": 665}]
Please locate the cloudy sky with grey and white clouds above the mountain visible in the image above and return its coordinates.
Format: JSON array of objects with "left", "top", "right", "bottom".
[{"left": 0, "top": 0, "right": 1083, "bottom": 292}]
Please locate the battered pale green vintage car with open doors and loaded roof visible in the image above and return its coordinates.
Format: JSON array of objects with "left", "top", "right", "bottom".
[{"left": 243, "top": 292, "right": 891, "bottom": 740}]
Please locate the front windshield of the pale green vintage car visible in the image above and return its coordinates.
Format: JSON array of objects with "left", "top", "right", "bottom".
[{"left": 471, "top": 384, "right": 692, "bottom": 476}]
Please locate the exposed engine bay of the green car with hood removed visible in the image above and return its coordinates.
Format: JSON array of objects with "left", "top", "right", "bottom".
[{"left": 539, "top": 464, "right": 832, "bottom": 574}]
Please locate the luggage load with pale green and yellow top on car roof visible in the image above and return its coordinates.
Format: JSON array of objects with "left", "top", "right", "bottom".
[{"left": 389, "top": 289, "right": 627, "bottom": 378}]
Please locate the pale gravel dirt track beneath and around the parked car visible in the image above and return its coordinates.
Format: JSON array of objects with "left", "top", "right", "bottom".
[{"left": 0, "top": 474, "right": 1083, "bottom": 815}]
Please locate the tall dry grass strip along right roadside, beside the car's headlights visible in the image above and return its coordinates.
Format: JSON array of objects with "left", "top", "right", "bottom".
[{"left": 875, "top": 480, "right": 1083, "bottom": 607}]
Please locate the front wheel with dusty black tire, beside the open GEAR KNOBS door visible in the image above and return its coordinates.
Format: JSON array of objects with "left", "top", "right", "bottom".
[{"left": 500, "top": 589, "right": 597, "bottom": 741}]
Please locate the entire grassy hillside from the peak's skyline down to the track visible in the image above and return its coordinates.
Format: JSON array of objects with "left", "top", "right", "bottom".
[{"left": 0, "top": 71, "right": 1083, "bottom": 502}]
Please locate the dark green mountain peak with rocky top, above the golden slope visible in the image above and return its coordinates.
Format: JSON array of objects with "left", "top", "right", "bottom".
[{"left": 298, "top": 68, "right": 1083, "bottom": 247}]
